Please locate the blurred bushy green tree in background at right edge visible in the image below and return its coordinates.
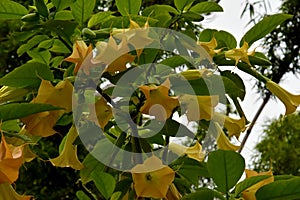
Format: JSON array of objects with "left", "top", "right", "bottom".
[{"left": 253, "top": 113, "right": 300, "bottom": 176}]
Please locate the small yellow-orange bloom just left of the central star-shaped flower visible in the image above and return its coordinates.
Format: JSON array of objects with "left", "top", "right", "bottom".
[{"left": 89, "top": 97, "right": 113, "bottom": 129}]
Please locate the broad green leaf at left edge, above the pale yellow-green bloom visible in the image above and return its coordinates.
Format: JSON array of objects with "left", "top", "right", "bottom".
[{"left": 0, "top": 62, "right": 53, "bottom": 88}]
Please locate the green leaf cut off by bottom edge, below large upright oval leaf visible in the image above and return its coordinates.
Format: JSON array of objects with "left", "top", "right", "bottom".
[{"left": 182, "top": 188, "right": 225, "bottom": 200}]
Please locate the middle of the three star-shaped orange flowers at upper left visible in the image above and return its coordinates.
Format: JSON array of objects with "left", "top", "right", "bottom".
[{"left": 92, "top": 36, "right": 135, "bottom": 73}]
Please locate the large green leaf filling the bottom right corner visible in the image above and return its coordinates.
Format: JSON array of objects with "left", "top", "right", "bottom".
[{"left": 255, "top": 177, "right": 300, "bottom": 200}]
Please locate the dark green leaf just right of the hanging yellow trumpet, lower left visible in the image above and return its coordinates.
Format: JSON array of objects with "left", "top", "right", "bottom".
[{"left": 79, "top": 154, "right": 105, "bottom": 184}]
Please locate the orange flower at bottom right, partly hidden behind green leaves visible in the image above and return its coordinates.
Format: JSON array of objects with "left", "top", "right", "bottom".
[{"left": 242, "top": 169, "right": 274, "bottom": 200}]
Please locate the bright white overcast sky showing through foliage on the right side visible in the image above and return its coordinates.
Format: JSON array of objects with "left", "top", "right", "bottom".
[{"left": 204, "top": 0, "right": 300, "bottom": 166}]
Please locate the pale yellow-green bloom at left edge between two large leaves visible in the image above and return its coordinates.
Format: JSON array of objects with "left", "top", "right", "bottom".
[{"left": 0, "top": 86, "right": 28, "bottom": 104}]
